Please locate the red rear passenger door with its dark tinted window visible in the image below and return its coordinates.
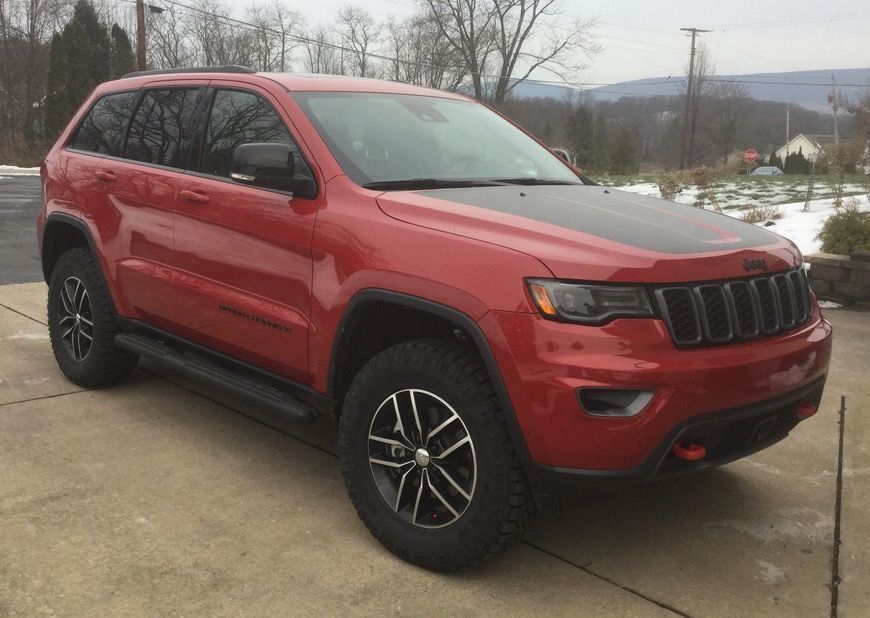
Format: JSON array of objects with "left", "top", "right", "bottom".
[{"left": 99, "top": 82, "right": 206, "bottom": 328}]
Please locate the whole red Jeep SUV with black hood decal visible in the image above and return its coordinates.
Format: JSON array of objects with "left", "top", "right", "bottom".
[{"left": 38, "top": 67, "right": 831, "bottom": 570}]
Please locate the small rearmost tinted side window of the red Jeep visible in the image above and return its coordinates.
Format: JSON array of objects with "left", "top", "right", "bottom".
[{"left": 69, "top": 91, "right": 139, "bottom": 157}]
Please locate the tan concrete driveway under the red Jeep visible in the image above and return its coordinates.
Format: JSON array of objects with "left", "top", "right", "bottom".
[{"left": 0, "top": 283, "right": 870, "bottom": 617}]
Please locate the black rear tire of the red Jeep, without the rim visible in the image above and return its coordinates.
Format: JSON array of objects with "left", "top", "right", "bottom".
[{"left": 48, "top": 248, "right": 139, "bottom": 388}]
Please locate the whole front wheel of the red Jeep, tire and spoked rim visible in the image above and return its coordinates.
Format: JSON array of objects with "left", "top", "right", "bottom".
[{"left": 339, "top": 339, "right": 533, "bottom": 570}]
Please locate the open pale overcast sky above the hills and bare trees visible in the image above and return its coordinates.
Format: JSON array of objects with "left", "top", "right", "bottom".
[{"left": 289, "top": 0, "right": 870, "bottom": 83}]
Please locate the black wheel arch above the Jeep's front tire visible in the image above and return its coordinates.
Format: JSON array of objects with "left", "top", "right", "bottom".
[{"left": 327, "top": 288, "right": 531, "bottom": 468}]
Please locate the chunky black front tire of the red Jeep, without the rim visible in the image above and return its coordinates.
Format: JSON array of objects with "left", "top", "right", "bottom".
[{"left": 338, "top": 339, "right": 534, "bottom": 571}]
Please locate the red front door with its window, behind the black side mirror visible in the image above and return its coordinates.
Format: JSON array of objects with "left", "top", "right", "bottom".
[{"left": 173, "top": 81, "right": 319, "bottom": 380}]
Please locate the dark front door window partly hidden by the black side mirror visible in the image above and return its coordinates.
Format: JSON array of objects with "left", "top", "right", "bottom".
[{"left": 199, "top": 90, "right": 310, "bottom": 178}]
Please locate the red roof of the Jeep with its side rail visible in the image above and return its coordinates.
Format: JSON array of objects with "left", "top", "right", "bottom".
[{"left": 109, "top": 67, "right": 470, "bottom": 101}]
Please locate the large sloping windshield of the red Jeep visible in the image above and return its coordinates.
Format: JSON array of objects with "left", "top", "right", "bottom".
[{"left": 293, "top": 92, "right": 582, "bottom": 189}]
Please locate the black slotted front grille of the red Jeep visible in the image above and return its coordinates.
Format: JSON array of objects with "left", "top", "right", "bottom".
[{"left": 655, "top": 268, "right": 812, "bottom": 347}]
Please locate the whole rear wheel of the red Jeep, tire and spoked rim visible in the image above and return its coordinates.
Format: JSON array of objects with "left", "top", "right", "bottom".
[{"left": 48, "top": 248, "right": 138, "bottom": 388}]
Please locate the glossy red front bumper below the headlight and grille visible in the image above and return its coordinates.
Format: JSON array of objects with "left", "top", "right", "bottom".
[{"left": 480, "top": 310, "right": 831, "bottom": 472}]
